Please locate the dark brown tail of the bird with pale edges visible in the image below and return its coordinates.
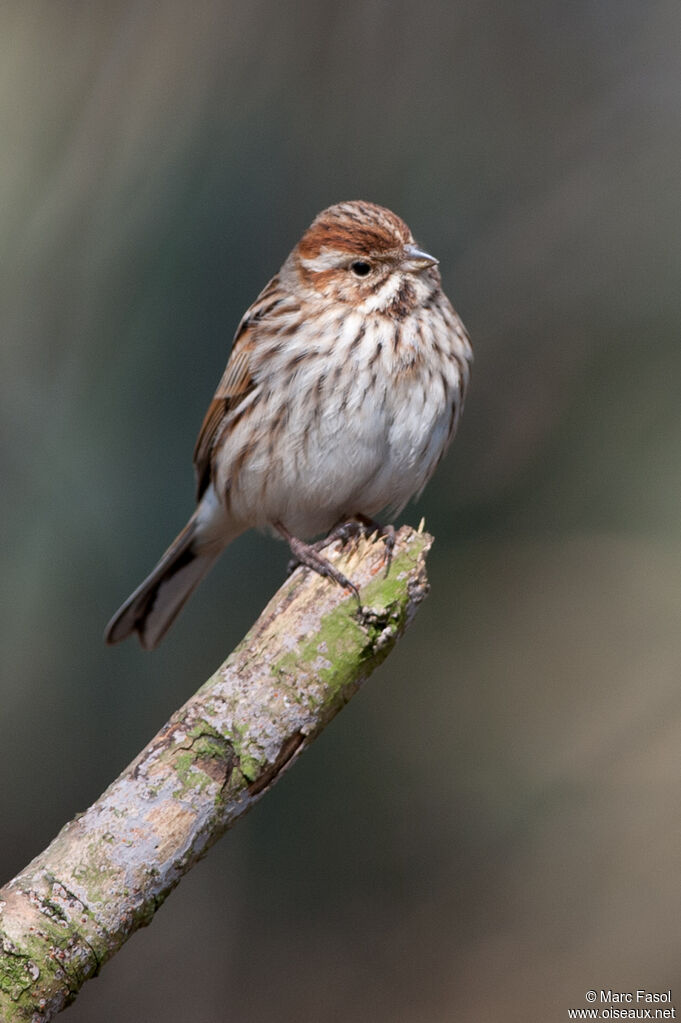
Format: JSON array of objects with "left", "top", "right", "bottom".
[{"left": 104, "top": 515, "right": 222, "bottom": 650}]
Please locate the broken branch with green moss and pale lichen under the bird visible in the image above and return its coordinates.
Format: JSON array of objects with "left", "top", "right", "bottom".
[{"left": 0, "top": 527, "right": 432, "bottom": 1023}]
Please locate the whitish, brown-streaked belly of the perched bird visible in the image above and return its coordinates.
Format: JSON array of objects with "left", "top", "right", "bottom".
[{"left": 218, "top": 337, "right": 459, "bottom": 539}]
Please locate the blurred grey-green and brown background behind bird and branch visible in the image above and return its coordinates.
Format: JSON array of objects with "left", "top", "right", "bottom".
[{"left": 0, "top": 0, "right": 681, "bottom": 1023}]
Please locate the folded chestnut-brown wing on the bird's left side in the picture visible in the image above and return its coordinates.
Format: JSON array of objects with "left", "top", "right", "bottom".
[{"left": 194, "top": 277, "right": 281, "bottom": 500}]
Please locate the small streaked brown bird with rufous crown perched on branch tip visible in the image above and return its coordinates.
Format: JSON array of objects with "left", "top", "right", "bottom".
[{"left": 105, "top": 202, "right": 472, "bottom": 650}]
